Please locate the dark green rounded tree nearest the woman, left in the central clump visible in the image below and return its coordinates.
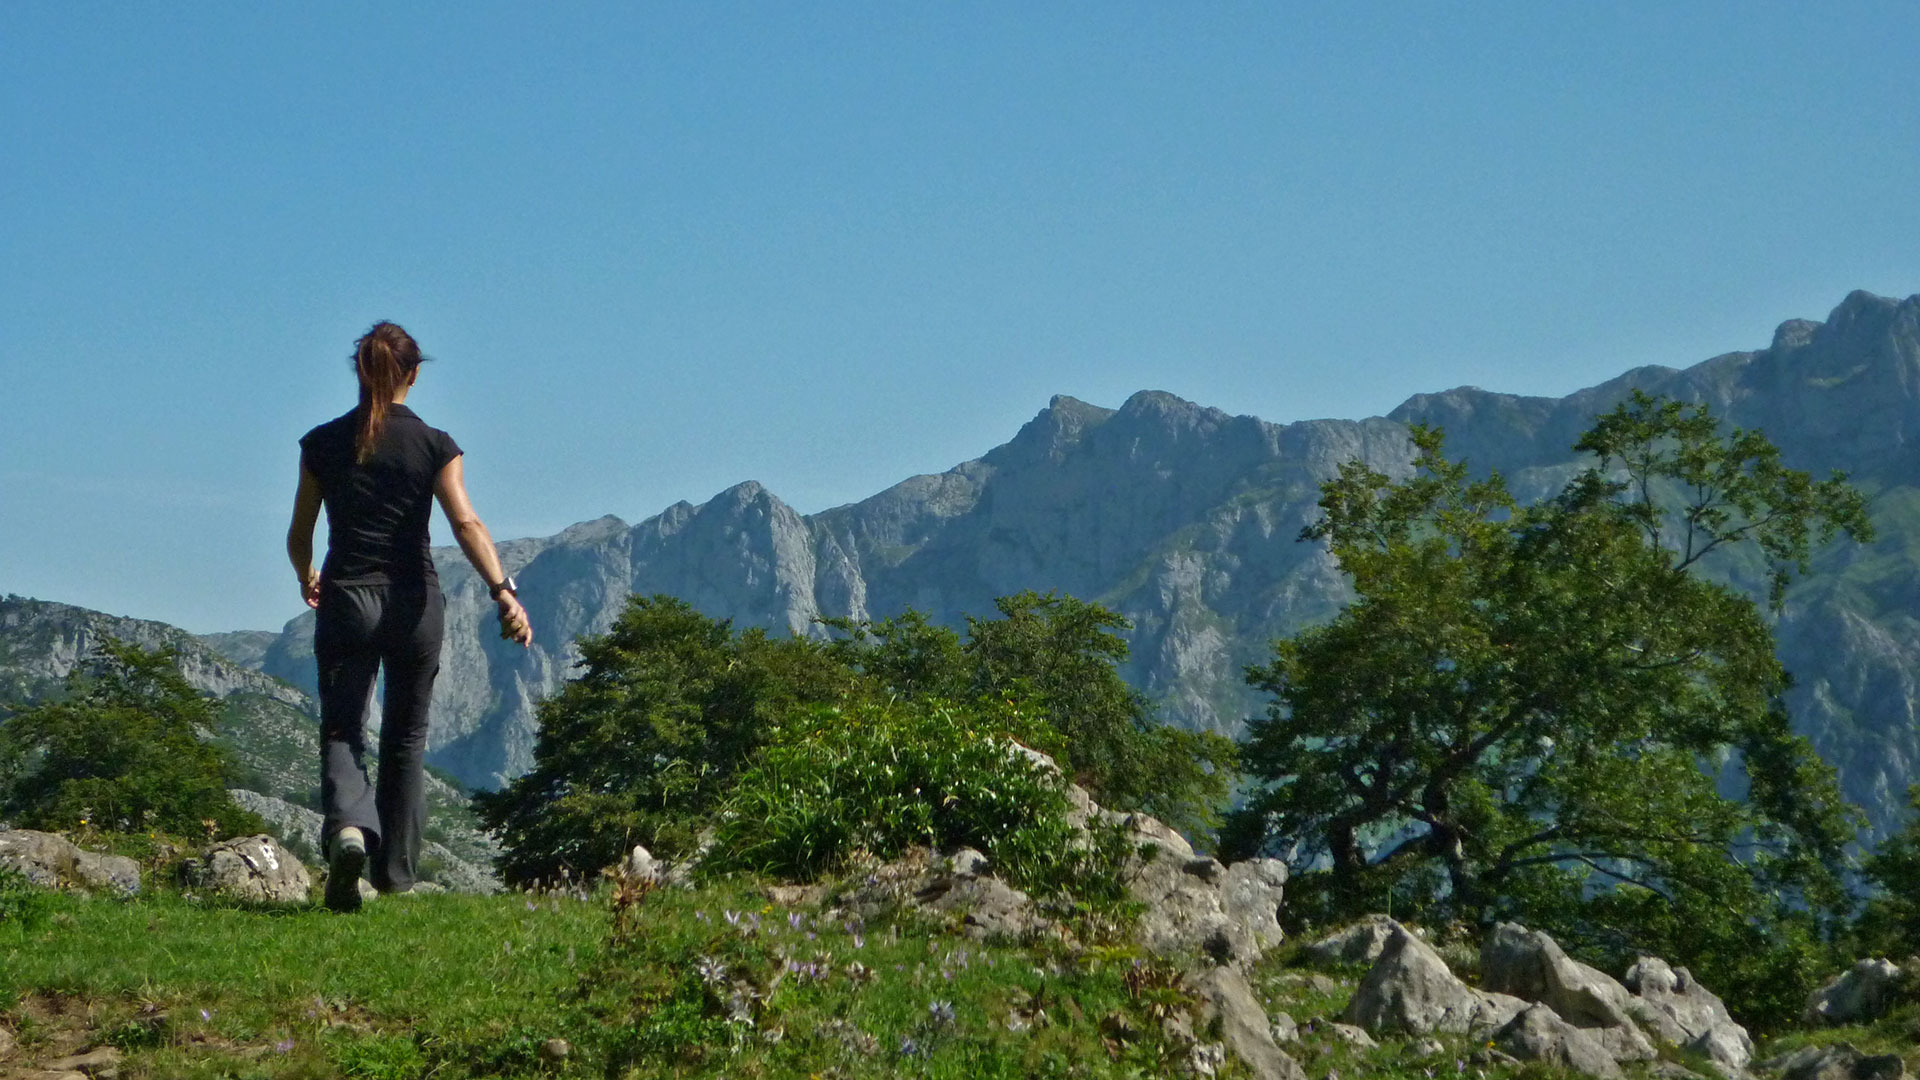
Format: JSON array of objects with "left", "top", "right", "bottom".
[{"left": 474, "top": 596, "right": 856, "bottom": 884}]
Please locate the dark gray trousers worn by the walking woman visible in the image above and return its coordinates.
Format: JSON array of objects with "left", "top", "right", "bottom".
[{"left": 313, "top": 582, "right": 445, "bottom": 892}]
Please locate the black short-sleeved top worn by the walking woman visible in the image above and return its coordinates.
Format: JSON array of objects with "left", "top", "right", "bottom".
[{"left": 300, "top": 405, "right": 461, "bottom": 584}]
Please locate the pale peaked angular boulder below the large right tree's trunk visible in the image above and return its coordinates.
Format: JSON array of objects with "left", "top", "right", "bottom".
[{"left": 1340, "top": 922, "right": 1526, "bottom": 1036}]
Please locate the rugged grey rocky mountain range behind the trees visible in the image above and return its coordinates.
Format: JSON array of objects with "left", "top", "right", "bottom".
[{"left": 15, "top": 292, "right": 1920, "bottom": 845}]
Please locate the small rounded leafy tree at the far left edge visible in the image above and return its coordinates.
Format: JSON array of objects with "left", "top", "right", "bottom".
[{"left": 0, "top": 638, "right": 265, "bottom": 836}]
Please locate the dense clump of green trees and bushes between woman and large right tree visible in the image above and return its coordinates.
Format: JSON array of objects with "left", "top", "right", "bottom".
[{"left": 474, "top": 594, "right": 1233, "bottom": 884}]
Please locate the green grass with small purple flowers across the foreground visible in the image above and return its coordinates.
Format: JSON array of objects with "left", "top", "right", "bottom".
[{"left": 0, "top": 878, "right": 1896, "bottom": 1080}]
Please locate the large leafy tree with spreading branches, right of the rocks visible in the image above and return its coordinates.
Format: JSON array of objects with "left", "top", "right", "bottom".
[{"left": 1225, "top": 394, "right": 1870, "bottom": 1009}]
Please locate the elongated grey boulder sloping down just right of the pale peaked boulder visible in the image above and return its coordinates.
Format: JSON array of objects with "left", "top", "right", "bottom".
[{"left": 1480, "top": 922, "right": 1657, "bottom": 1061}]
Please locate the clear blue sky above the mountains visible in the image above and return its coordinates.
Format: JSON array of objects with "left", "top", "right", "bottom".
[{"left": 0, "top": 2, "right": 1920, "bottom": 632}]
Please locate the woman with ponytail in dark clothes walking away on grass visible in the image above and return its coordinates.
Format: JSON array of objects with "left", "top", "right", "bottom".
[{"left": 286, "top": 323, "right": 534, "bottom": 911}]
